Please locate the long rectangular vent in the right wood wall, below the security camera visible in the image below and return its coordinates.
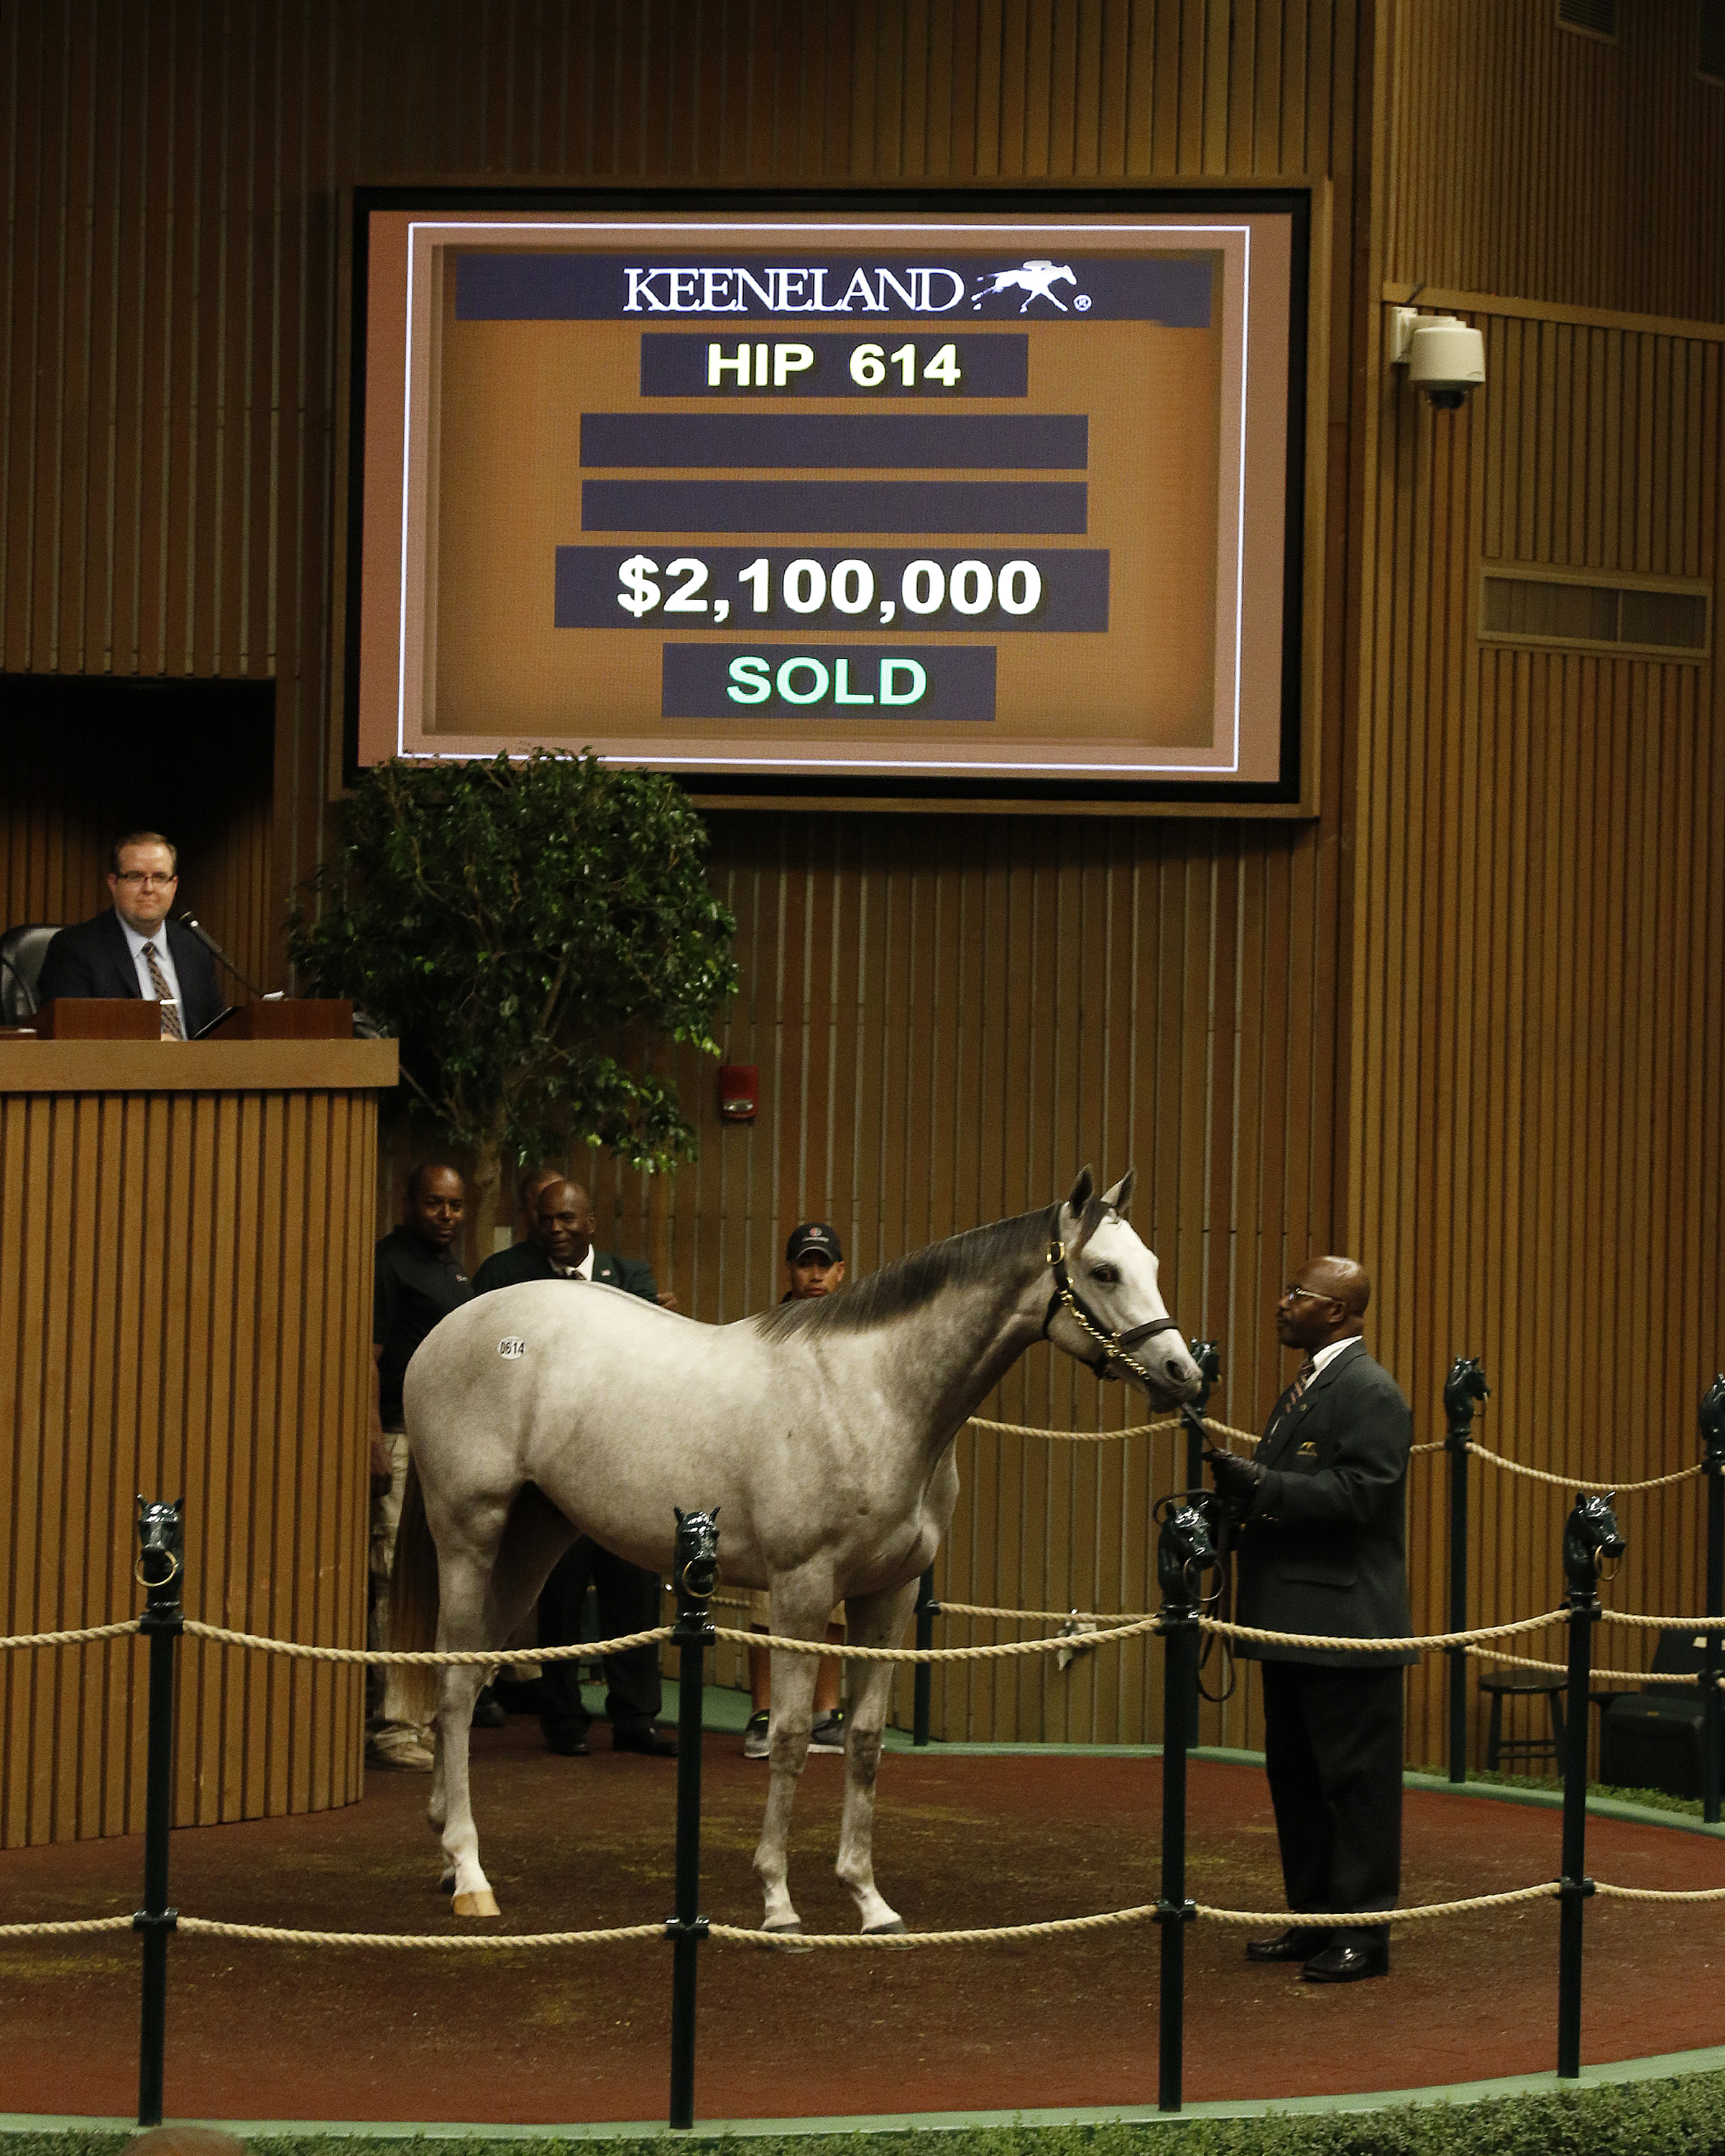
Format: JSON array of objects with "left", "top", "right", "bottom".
[{"left": 1479, "top": 563, "right": 1712, "bottom": 664}]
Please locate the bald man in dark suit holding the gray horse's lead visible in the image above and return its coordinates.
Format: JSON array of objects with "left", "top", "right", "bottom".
[{"left": 1205, "top": 1257, "right": 1417, "bottom": 1984}]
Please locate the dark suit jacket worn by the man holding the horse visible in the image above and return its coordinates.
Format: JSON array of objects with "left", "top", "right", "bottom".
[{"left": 1236, "top": 1341, "right": 1419, "bottom": 1669}]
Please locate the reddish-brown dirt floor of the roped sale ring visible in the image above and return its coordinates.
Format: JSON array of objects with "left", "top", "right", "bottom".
[{"left": 0, "top": 1718, "right": 1725, "bottom": 2124}]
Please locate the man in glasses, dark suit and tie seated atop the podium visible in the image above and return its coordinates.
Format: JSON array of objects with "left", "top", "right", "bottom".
[{"left": 37, "top": 830, "right": 224, "bottom": 1041}]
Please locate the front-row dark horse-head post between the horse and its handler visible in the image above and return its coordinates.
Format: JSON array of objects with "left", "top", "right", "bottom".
[{"left": 1156, "top": 1498, "right": 1216, "bottom": 2111}]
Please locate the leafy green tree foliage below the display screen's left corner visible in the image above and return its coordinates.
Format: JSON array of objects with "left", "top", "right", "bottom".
[{"left": 289, "top": 752, "right": 737, "bottom": 1184}]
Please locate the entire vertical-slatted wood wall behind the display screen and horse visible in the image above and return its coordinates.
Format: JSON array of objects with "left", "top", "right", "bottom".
[{"left": 0, "top": 0, "right": 1725, "bottom": 1755}]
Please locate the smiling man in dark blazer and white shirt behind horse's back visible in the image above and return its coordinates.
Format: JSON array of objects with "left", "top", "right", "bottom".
[{"left": 472, "top": 1177, "right": 677, "bottom": 1759}]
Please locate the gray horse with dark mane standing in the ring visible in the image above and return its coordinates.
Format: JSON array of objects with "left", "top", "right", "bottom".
[{"left": 390, "top": 1169, "right": 1199, "bottom": 1932}]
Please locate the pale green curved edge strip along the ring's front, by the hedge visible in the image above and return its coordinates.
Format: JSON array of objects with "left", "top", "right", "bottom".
[{"left": 0, "top": 2044, "right": 1725, "bottom": 2145}]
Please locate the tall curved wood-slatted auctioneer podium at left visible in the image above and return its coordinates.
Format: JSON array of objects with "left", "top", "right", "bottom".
[{"left": 0, "top": 1005, "right": 397, "bottom": 1848}]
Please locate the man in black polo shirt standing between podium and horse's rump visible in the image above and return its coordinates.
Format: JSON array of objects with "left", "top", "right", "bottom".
[{"left": 364, "top": 1166, "right": 472, "bottom": 1770}]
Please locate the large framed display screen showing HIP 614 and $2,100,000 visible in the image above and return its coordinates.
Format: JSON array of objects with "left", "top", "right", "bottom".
[{"left": 347, "top": 190, "right": 1307, "bottom": 802}]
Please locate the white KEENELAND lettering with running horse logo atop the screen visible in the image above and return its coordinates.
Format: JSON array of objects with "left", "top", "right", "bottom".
[{"left": 623, "top": 259, "right": 1091, "bottom": 315}]
